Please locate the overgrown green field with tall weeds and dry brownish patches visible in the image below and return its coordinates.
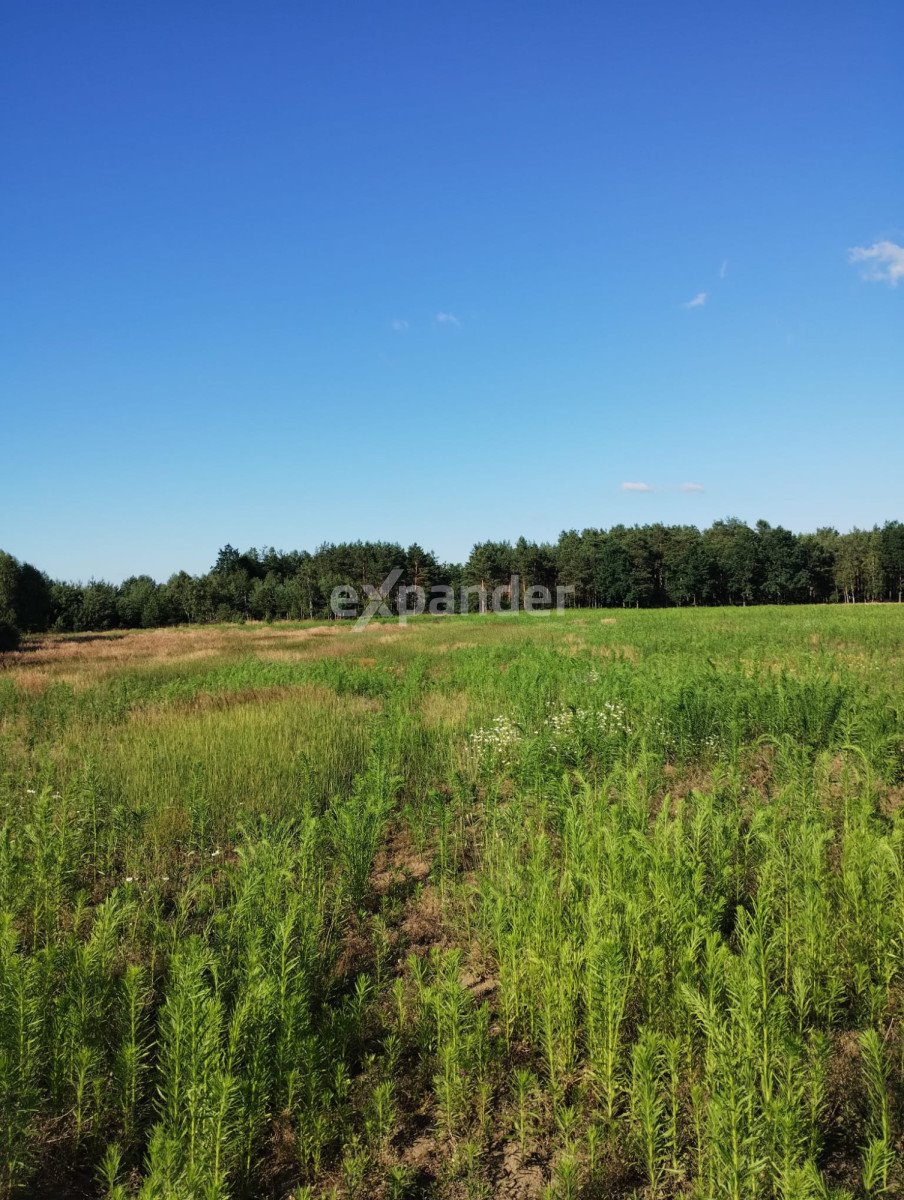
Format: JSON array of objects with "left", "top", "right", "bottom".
[{"left": 0, "top": 605, "right": 904, "bottom": 1200}]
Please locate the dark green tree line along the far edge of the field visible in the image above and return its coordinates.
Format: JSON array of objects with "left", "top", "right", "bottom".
[{"left": 0, "top": 518, "right": 904, "bottom": 649}]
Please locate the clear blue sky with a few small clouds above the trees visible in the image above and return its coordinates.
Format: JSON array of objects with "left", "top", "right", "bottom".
[{"left": 0, "top": 0, "right": 904, "bottom": 580}]
